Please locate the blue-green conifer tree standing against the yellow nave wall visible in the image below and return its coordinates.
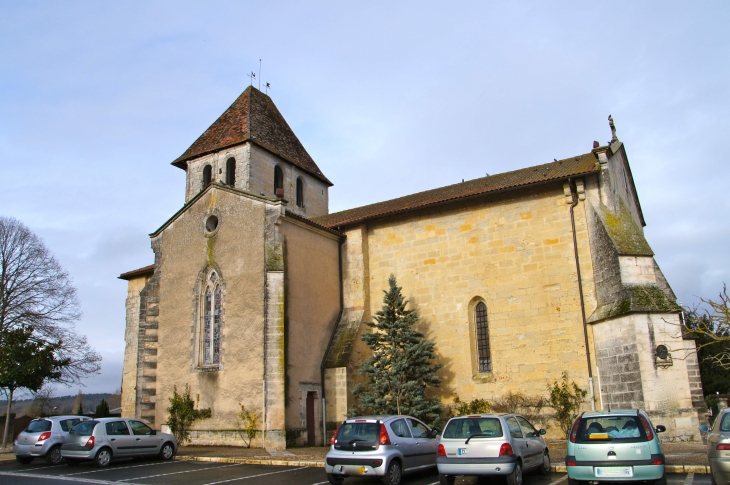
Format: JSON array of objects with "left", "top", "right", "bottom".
[{"left": 350, "top": 274, "right": 443, "bottom": 425}]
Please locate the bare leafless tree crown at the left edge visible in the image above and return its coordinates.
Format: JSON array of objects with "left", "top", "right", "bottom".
[{"left": 0, "top": 217, "right": 101, "bottom": 383}]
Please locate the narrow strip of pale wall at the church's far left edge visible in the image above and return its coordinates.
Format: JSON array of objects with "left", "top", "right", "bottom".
[{"left": 122, "top": 276, "right": 149, "bottom": 416}]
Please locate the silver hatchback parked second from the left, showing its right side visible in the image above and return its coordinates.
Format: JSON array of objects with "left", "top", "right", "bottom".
[{"left": 61, "top": 418, "right": 178, "bottom": 467}]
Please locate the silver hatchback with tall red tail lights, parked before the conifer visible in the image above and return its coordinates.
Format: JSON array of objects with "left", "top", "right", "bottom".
[{"left": 325, "top": 416, "right": 438, "bottom": 485}]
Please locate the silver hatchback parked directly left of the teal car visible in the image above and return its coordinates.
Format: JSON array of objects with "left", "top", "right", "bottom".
[{"left": 436, "top": 414, "right": 550, "bottom": 485}]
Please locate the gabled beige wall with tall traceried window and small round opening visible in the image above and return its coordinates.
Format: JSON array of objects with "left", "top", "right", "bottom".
[{"left": 155, "top": 187, "right": 272, "bottom": 444}]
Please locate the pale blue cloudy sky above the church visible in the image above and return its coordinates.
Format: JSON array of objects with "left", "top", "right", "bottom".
[{"left": 0, "top": 0, "right": 730, "bottom": 394}]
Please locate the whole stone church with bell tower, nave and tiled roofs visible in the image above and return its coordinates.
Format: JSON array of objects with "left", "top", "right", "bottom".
[{"left": 120, "top": 87, "right": 702, "bottom": 449}]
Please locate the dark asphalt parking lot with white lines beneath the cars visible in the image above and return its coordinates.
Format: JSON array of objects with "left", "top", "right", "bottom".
[{"left": 0, "top": 461, "right": 710, "bottom": 485}]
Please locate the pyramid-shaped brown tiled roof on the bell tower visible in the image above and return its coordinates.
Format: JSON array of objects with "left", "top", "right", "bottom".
[{"left": 172, "top": 86, "right": 332, "bottom": 186}]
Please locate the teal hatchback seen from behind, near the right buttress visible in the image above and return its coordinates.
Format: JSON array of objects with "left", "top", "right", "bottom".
[{"left": 565, "top": 409, "right": 667, "bottom": 485}]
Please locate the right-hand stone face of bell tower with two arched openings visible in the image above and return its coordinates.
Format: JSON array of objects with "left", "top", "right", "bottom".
[{"left": 246, "top": 145, "right": 329, "bottom": 218}]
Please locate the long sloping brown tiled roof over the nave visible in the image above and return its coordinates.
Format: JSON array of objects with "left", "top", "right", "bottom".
[{"left": 312, "top": 152, "right": 599, "bottom": 228}]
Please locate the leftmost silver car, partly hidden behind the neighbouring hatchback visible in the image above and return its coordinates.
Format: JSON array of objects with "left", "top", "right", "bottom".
[{"left": 13, "top": 416, "right": 91, "bottom": 465}]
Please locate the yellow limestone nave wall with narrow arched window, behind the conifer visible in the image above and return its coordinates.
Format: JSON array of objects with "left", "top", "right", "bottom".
[{"left": 345, "top": 184, "right": 595, "bottom": 410}]
